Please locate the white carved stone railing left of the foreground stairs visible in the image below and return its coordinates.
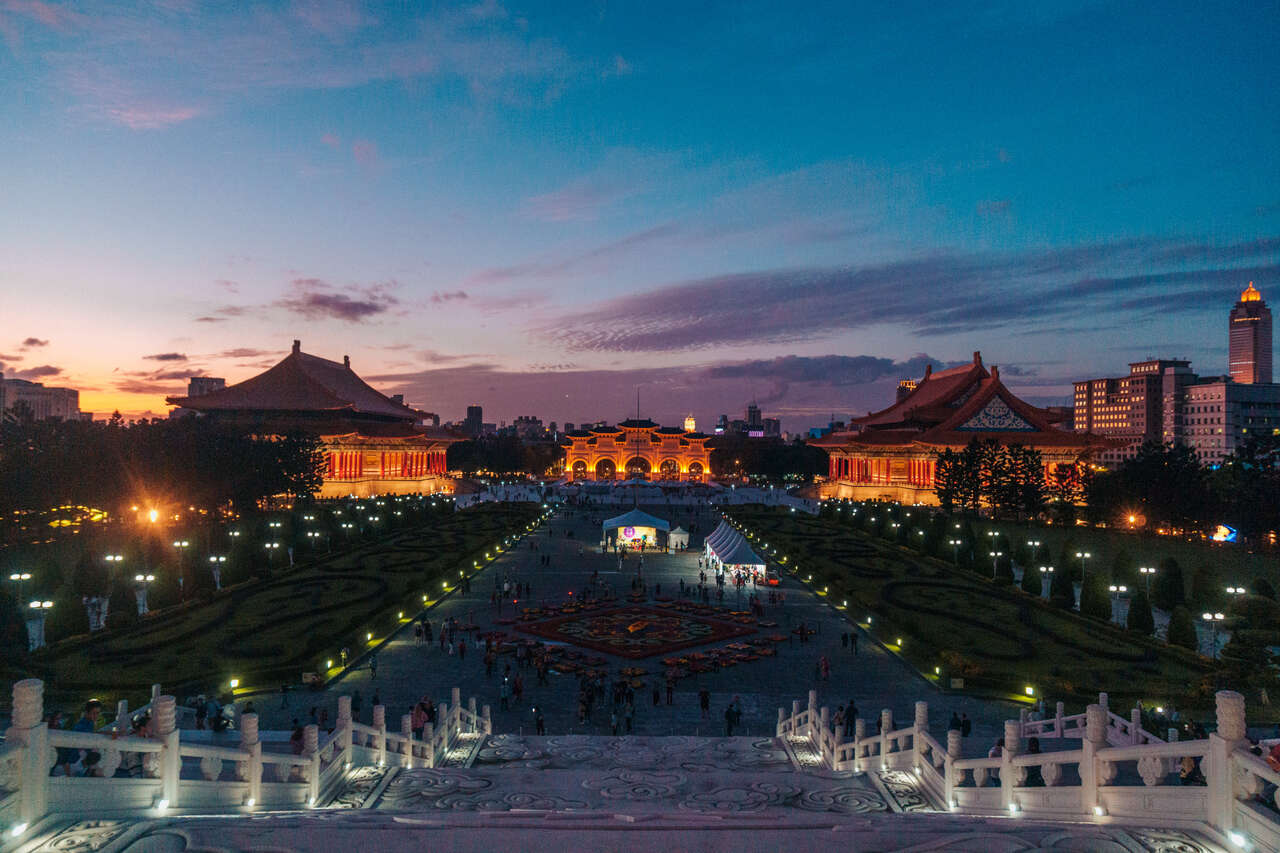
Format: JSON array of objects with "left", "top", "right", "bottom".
[{"left": 0, "top": 679, "right": 492, "bottom": 839}]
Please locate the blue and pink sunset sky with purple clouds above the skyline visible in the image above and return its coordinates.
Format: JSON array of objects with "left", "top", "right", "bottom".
[{"left": 0, "top": 0, "right": 1280, "bottom": 430}]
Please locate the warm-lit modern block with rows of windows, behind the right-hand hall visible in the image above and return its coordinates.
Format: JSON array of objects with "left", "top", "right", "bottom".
[{"left": 1071, "top": 359, "right": 1194, "bottom": 465}]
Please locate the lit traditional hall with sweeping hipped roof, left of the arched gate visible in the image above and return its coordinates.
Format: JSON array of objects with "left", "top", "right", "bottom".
[{"left": 165, "top": 341, "right": 461, "bottom": 497}]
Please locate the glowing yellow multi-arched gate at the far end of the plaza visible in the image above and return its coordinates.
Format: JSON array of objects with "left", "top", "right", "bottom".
[{"left": 564, "top": 419, "right": 712, "bottom": 483}]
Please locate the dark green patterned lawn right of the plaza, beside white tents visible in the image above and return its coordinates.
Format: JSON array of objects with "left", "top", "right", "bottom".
[{"left": 732, "top": 507, "right": 1208, "bottom": 707}]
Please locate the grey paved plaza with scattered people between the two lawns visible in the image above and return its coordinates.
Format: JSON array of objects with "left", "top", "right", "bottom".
[{"left": 255, "top": 506, "right": 1018, "bottom": 754}]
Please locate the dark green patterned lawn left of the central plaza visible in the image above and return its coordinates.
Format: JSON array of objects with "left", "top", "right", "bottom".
[{"left": 20, "top": 503, "right": 541, "bottom": 703}]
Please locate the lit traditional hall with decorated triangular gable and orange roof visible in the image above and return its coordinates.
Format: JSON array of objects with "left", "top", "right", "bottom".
[{"left": 809, "top": 352, "right": 1110, "bottom": 505}]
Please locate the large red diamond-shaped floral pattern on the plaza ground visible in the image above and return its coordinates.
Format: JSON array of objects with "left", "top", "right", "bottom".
[{"left": 517, "top": 606, "right": 755, "bottom": 658}]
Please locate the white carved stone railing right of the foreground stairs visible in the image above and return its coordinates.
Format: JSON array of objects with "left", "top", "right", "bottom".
[{"left": 777, "top": 690, "right": 1280, "bottom": 850}]
